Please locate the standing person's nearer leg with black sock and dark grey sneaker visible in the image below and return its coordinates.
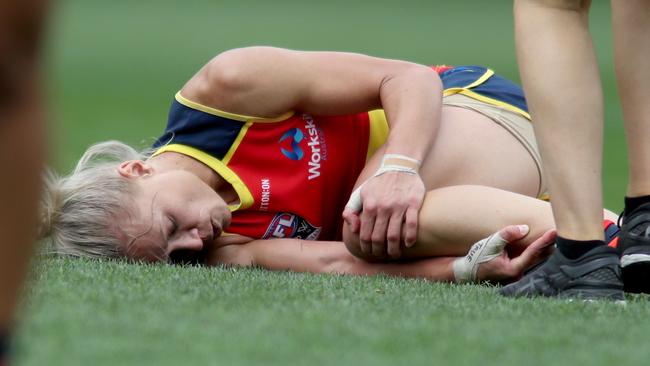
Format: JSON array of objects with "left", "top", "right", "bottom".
[{"left": 502, "top": 0, "right": 623, "bottom": 299}]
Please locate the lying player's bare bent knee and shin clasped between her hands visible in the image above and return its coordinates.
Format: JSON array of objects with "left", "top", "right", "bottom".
[{"left": 343, "top": 185, "right": 618, "bottom": 260}]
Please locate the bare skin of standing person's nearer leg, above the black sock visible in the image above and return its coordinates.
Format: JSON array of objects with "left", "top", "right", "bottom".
[{"left": 515, "top": 0, "right": 603, "bottom": 240}]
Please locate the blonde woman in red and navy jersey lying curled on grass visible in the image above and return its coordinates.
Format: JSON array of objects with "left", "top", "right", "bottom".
[{"left": 44, "top": 47, "right": 616, "bottom": 280}]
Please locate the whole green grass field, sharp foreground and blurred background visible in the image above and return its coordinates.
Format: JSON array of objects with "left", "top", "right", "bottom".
[{"left": 11, "top": 0, "right": 650, "bottom": 366}]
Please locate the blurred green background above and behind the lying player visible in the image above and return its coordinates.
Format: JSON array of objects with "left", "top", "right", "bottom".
[{"left": 46, "top": 0, "right": 627, "bottom": 211}]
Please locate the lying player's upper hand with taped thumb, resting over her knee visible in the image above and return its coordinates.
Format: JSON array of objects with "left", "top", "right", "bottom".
[{"left": 343, "top": 171, "right": 425, "bottom": 258}]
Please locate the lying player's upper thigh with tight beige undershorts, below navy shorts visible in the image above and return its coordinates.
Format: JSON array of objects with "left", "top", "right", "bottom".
[{"left": 355, "top": 95, "right": 545, "bottom": 204}]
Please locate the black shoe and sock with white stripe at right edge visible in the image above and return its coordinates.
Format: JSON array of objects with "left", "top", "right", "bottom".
[{"left": 618, "top": 203, "right": 650, "bottom": 293}]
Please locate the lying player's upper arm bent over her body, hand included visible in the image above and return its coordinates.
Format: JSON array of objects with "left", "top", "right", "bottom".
[{"left": 181, "top": 47, "right": 442, "bottom": 255}]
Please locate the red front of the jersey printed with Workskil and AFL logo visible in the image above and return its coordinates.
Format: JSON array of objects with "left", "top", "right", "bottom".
[{"left": 220, "top": 113, "right": 369, "bottom": 240}]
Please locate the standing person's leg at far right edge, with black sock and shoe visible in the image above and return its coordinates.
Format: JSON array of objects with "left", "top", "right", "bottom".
[{"left": 612, "top": 0, "right": 650, "bottom": 292}]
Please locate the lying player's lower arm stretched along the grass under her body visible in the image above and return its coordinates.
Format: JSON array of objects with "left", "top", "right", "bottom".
[{"left": 207, "top": 226, "right": 554, "bottom": 282}]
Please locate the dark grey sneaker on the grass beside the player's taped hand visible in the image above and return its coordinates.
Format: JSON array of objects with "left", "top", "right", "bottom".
[{"left": 499, "top": 245, "right": 625, "bottom": 301}]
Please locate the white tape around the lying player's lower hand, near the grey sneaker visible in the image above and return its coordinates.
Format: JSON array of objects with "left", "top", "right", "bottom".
[{"left": 453, "top": 232, "right": 508, "bottom": 283}]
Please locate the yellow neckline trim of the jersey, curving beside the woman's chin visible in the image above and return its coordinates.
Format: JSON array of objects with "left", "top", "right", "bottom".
[{"left": 152, "top": 144, "right": 254, "bottom": 211}]
